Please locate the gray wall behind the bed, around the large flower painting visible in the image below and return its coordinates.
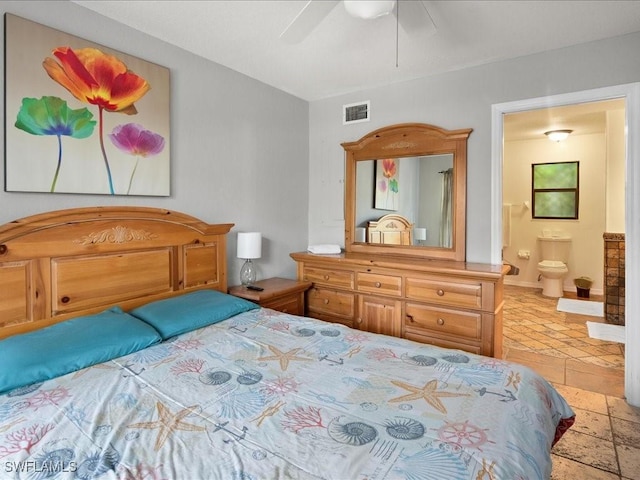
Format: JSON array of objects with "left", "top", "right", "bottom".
[{"left": 0, "top": 1, "right": 309, "bottom": 285}]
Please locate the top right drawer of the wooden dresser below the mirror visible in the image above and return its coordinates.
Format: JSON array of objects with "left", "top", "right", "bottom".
[{"left": 405, "top": 277, "right": 483, "bottom": 309}]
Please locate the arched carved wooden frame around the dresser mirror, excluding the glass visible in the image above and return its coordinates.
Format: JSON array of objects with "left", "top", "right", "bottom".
[{"left": 342, "top": 123, "right": 472, "bottom": 261}]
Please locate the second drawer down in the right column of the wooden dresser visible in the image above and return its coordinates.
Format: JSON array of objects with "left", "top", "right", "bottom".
[{"left": 404, "top": 303, "right": 482, "bottom": 341}]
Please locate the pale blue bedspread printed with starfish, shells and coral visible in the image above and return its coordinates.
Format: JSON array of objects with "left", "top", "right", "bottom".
[{"left": 0, "top": 309, "right": 574, "bottom": 480}]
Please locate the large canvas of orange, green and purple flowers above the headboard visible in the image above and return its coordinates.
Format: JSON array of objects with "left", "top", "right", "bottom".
[{"left": 5, "top": 13, "right": 171, "bottom": 196}]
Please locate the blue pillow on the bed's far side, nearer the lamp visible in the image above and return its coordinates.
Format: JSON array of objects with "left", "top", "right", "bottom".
[{"left": 129, "top": 290, "right": 260, "bottom": 340}]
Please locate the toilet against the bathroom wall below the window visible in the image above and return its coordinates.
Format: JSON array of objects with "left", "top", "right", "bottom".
[{"left": 538, "top": 231, "right": 571, "bottom": 298}]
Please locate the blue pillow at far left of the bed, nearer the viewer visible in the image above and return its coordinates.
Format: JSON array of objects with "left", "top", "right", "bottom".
[{"left": 0, "top": 307, "right": 162, "bottom": 393}]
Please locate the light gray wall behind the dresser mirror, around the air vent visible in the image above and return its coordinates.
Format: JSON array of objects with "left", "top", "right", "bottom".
[{"left": 309, "top": 34, "right": 640, "bottom": 263}]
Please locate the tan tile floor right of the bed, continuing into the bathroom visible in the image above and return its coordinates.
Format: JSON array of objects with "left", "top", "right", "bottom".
[{"left": 503, "top": 286, "right": 640, "bottom": 480}]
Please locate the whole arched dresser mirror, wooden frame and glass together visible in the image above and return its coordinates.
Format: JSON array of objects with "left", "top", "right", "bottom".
[{"left": 342, "top": 123, "right": 472, "bottom": 261}]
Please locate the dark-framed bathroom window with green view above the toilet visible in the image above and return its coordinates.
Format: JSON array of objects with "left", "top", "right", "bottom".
[{"left": 531, "top": 162, "right": 580, "bottom": 220}]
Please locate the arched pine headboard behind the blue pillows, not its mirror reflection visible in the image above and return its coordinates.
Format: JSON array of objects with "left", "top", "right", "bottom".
[{"left": 0, "top": 207, "right": 233, "bottom": 338}]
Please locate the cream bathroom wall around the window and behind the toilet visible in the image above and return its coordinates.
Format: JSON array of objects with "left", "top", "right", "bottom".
[{"left": 502, "top": 134, "right": 608, "bottom": 294}]
